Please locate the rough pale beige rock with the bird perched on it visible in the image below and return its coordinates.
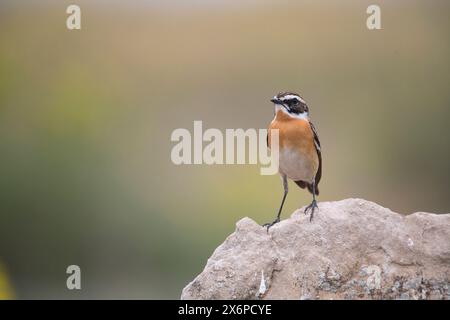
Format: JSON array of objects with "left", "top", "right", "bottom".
[{"left": 181, "top": 199, "right": 450, "bottom": 300}]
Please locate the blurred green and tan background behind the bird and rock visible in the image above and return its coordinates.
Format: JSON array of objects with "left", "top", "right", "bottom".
[{"left": 0, "top": 0, "right": 450, "bottom": 299}]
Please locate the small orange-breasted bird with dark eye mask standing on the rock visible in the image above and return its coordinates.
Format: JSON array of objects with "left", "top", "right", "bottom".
[{"left": 263, "top": 92, "right": 322, "bottom": 231}]
